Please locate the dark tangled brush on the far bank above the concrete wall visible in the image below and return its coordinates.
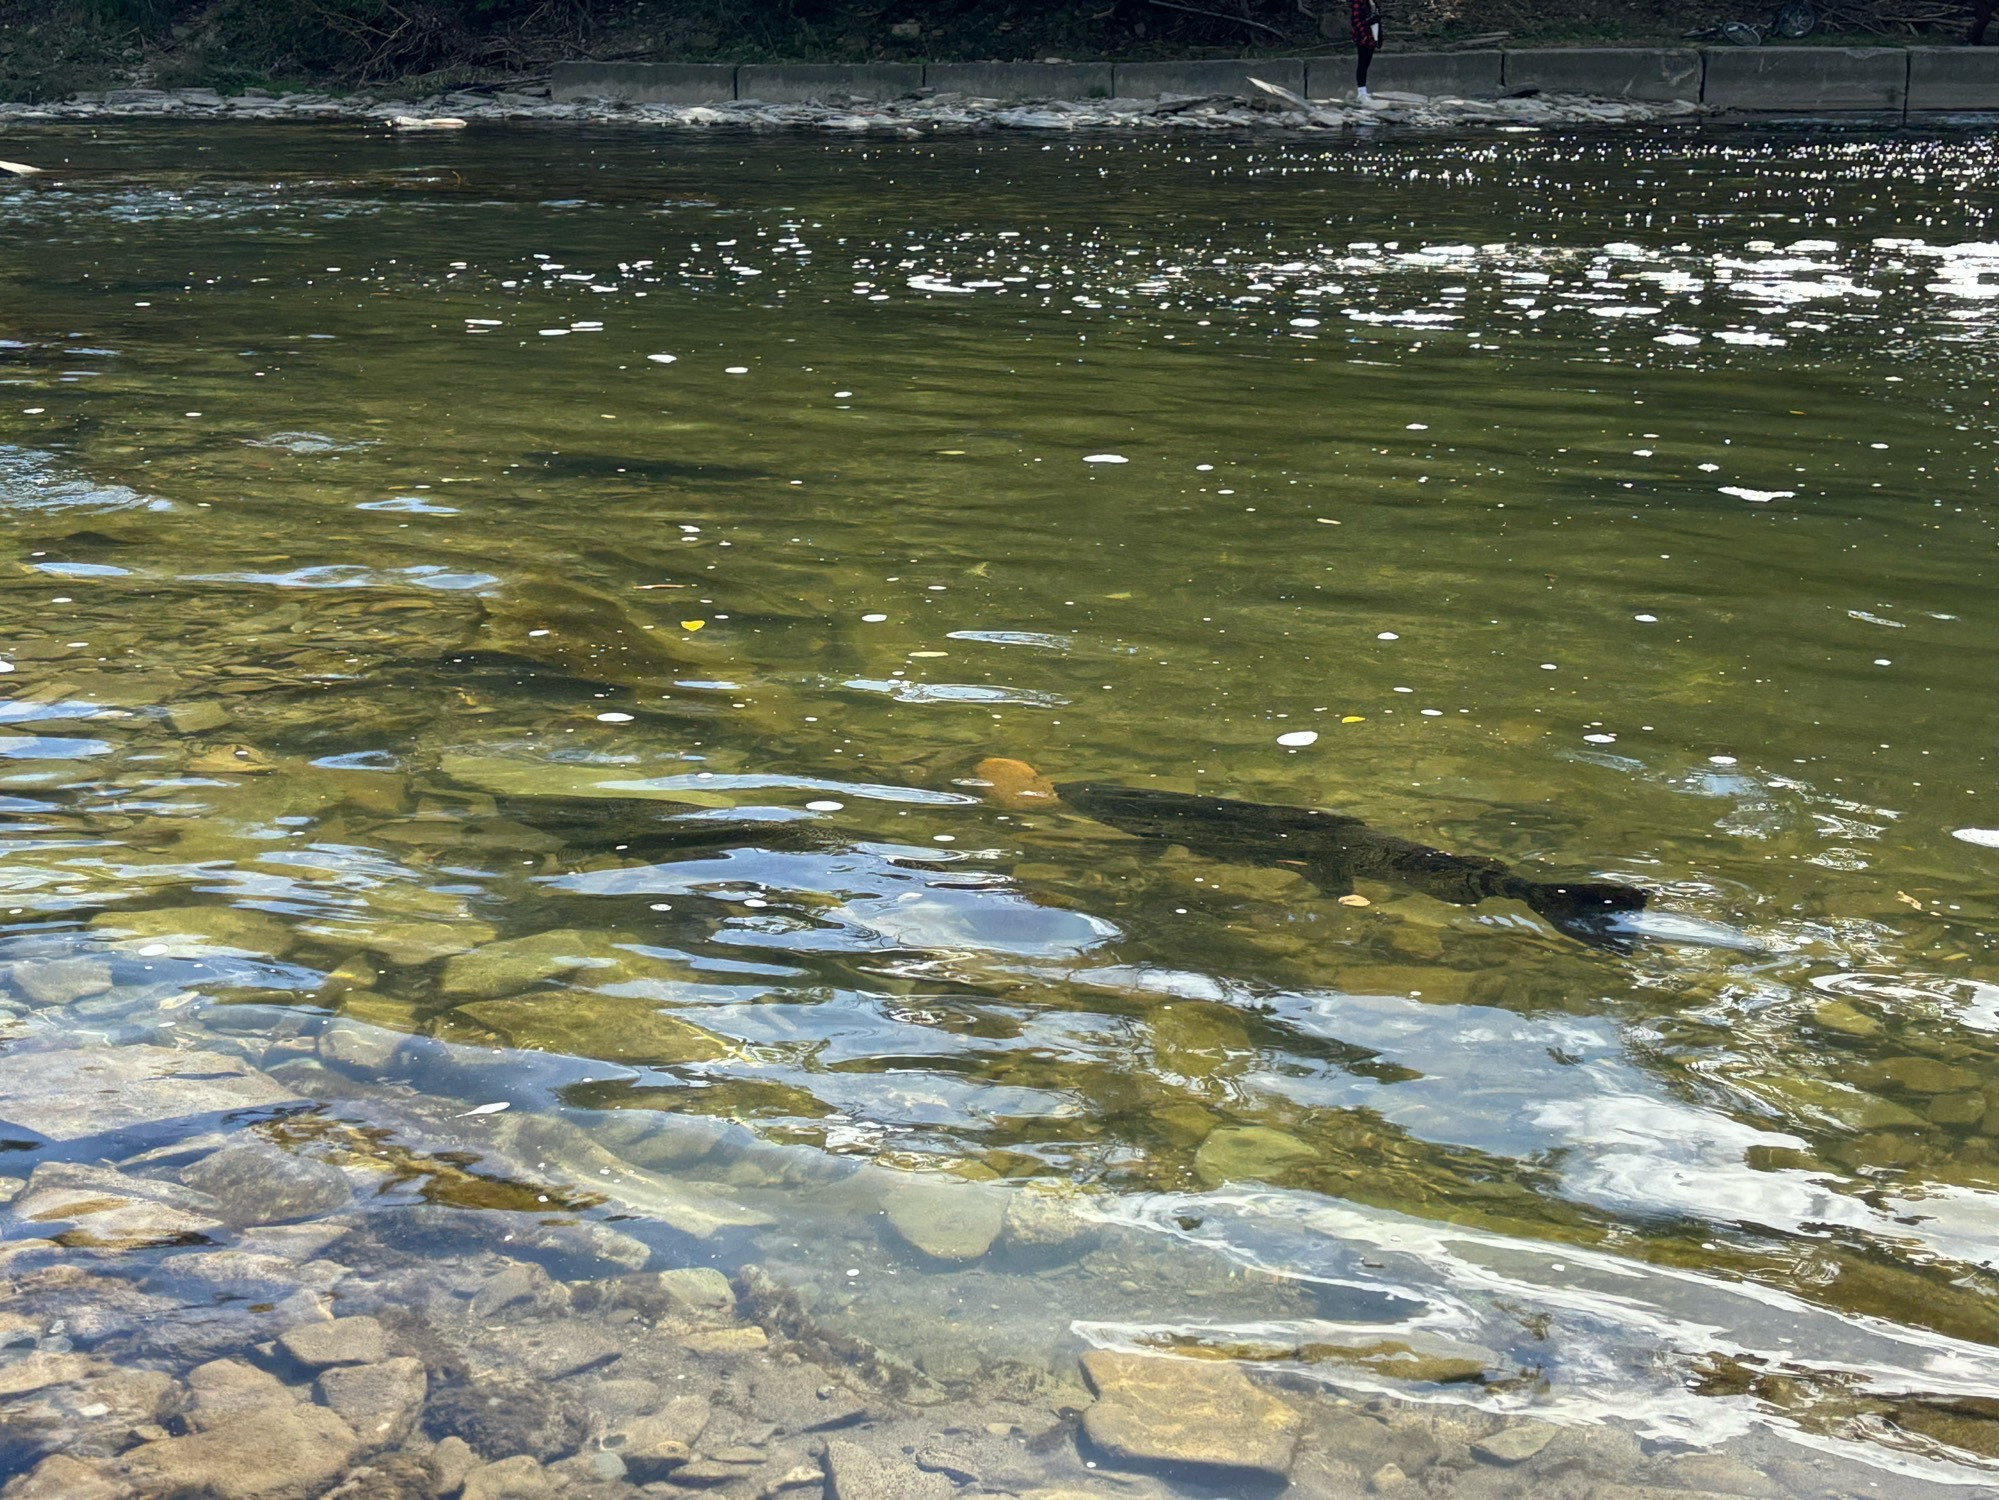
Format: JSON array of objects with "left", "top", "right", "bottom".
[{"left": 0, "top": 0, "right": 1969, "bottom": 98}]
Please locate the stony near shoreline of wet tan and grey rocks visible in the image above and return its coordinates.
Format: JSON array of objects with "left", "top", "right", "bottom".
[{"left": 0, "top": 976, "right": 1887, "bottom": 1500}]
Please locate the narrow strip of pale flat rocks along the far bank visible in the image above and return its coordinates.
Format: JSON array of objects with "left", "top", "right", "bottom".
[{"left": 0, "top": 88, "right": 1701, "bottom": 136}]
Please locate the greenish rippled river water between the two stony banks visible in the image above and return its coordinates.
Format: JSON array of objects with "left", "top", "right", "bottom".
[{"left": 0, "top": 128, "right": 1999, "bottom": 1482}]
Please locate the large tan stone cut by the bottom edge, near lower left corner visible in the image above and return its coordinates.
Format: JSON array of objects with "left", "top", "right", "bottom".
[{"left": 118, "top": 1402, "right": 360, "bottom": 1500}]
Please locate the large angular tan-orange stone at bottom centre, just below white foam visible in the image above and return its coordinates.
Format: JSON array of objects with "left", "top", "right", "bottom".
[{"left": 1083, "top": 1350, "right": 1301, "bottom": 1478}]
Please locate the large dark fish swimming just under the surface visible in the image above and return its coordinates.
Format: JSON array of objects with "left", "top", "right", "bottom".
[{"left": 1053, "top": 782, "right": 1649, "bottom": 948}]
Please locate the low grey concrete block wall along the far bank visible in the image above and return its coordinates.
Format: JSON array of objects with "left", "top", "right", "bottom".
[{"left": 550, "top": 46, "right": 1999, "bottom": 114}]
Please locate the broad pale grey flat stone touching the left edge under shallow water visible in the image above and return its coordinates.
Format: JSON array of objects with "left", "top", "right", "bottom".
[{"left": 0, "top": 1046, "right": 302, "bottom": 1142}]
